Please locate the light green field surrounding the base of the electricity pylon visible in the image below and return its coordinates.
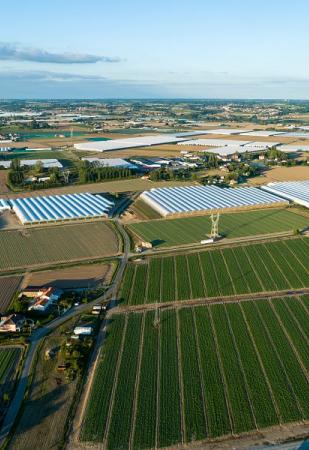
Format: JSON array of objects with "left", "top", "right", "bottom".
[{"left": 128, "top": 209, "right": 309, "bottom": 247}]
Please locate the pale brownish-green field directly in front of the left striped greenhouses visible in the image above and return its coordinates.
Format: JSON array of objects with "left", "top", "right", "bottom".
[{"left": 0, "top": 221, "right": 118, "bottom": 271}]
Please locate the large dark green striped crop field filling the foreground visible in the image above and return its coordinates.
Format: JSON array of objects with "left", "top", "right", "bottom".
[{"left": 80, "top": 297, "right": 309, "bottom": 449}]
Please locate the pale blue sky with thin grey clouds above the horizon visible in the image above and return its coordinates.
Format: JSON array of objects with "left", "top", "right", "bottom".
[{"left": 0, "top": 0, "right": 309, "bottom": 99}]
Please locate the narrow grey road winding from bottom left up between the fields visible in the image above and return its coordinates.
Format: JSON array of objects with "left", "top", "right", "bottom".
[{"left": 0, "top": 217, "right": 130, "bottom": 447}]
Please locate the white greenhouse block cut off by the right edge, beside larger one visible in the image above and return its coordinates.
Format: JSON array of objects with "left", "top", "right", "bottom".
[{"left": 262, "top": 180, "right": 309, "bottom": 208}]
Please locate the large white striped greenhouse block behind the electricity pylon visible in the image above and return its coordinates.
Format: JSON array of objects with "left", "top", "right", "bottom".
[{"left": 140, "top": 186, "right": 288, "bottom": 216}]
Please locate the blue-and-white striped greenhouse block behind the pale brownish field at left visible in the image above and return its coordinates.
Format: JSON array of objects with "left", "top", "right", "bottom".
[{"left": 10, "top": 193, "right": 114, "bottom": 225}]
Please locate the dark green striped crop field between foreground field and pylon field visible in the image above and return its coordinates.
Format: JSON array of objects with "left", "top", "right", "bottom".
[{"left": 120, "top": 238, "right": 309, "bottom": 305}]
